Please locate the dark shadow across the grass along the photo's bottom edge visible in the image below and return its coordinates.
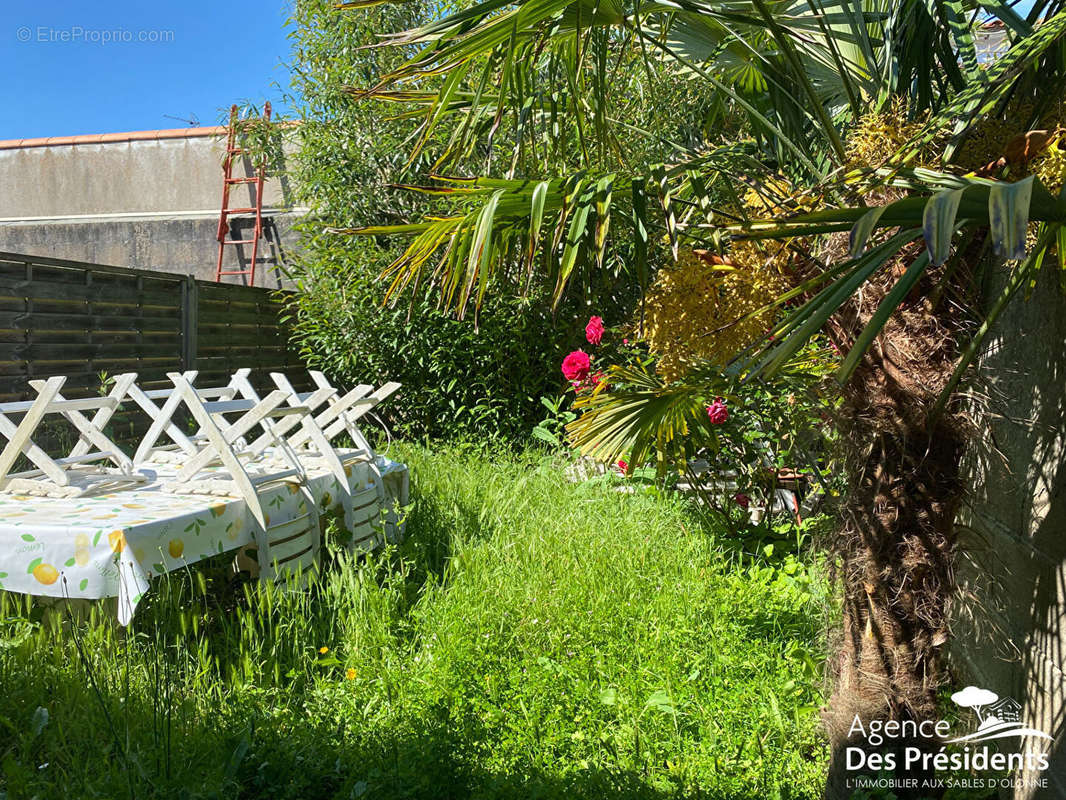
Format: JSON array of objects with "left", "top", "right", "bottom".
[{"left": 0, "top": 682, "right": 724, "bottom": 800}]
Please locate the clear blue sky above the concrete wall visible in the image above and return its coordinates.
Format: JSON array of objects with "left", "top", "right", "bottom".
[{"left": 0, "top": 0, "right": 289, "bottom": 139}]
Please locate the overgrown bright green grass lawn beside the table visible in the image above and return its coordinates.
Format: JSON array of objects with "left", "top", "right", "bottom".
[{"left": 0, "top": 447, "right": 826, "bottom": 800}]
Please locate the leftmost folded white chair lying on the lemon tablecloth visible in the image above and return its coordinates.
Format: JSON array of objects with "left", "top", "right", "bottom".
[{"left": 0, "top": 372, "right": 146, "bottom": 497}]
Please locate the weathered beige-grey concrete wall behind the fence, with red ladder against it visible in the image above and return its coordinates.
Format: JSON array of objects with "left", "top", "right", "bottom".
[{"left": 0, "top": 128, "right": 302, "bottom": 286}]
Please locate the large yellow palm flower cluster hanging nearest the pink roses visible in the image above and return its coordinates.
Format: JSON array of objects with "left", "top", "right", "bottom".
[{"left": 644, "top": 242, "right": 789, "bottom": 381}]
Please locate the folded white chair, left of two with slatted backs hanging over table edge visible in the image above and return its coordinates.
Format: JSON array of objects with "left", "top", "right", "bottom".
[{"left": 163, "top": 372, "right": 322, "bottom": 580}]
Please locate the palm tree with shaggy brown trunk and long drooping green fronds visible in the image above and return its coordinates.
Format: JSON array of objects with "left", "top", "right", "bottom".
[{"left": 334, "top": 0, "right": 1066, "bottom": 789}]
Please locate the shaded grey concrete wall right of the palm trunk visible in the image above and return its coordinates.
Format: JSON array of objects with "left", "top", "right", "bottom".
[{"left": 952, "top": 261, "right": 1066, "bottom": 798}]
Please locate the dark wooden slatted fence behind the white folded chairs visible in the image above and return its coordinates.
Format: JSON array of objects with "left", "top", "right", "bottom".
[{"left": 0, "top": 253, "right": 310, "bottom": 402}]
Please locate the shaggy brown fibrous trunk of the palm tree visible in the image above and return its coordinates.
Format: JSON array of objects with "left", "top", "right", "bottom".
[{"left": 824, "top": 260, "right": 963, "bottom": 797}]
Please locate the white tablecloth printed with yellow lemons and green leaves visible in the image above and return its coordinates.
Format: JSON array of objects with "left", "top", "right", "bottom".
[{"left": 0, "top": 458, "right": 408, "bottom": 625}]
